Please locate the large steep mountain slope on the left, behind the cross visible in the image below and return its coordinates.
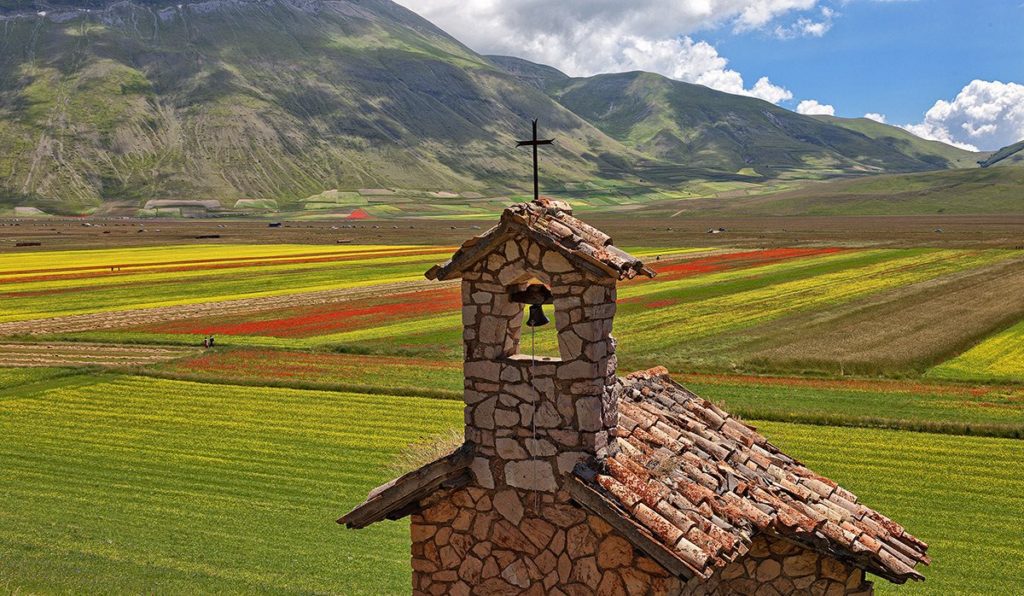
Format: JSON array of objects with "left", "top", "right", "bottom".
[{"left": 0, "top": 0, "right": 636, "bottom": 212}]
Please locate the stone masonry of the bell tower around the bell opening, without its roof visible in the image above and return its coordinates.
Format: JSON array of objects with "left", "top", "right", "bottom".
[{"left": 462, "top": 238, "right": 617, "bottom": 493}]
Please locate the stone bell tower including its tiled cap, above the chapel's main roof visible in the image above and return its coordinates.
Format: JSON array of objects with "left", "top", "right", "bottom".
[{"left": 428, "top": 199, "right": 639, "bottom": 494}]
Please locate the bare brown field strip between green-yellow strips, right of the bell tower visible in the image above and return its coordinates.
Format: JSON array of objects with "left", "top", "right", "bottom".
[{"left": 733, "top": 256, "right": 1024, "bottom": 374}]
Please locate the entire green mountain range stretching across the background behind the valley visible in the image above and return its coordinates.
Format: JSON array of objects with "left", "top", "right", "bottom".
[{"left": 0, "top": 0, "right": 1020, "bottom": 213}]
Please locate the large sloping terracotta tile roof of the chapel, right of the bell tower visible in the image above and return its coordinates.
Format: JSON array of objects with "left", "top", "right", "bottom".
[{"left": 575, "top": 368, "right": 930, "bottom": 583}]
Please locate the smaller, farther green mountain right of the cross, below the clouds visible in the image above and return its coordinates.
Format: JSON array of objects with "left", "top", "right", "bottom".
[{"left": 512, "top": 66, "right": 976, "bottom": 176}]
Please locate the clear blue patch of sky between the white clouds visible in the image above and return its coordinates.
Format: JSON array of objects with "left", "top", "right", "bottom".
[{"left": 712, "top": 0, "right": 1024, "bottom": 123}]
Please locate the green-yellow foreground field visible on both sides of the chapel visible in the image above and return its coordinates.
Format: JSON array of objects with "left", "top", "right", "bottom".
[{"left": 0, "top": 376, "right": 1024, "bottom": 594}]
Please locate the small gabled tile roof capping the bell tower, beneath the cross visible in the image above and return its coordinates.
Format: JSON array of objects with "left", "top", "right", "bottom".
[{"left": 426, "top": 197, "right": 654, "bottom": 280}]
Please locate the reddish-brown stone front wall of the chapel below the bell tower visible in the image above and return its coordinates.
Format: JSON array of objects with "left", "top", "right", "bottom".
[{"left": 412, "top": 487, "right": 683, "bottom": 596}]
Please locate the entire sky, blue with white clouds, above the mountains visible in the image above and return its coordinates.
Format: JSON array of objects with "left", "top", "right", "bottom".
[{"left": 398, "top": 0, "right": 1024, "bottom": 151}]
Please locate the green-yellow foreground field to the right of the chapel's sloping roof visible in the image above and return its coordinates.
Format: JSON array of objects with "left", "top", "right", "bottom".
[{"left": 757, "top": 422, "right": 1024, "bottom": 594}]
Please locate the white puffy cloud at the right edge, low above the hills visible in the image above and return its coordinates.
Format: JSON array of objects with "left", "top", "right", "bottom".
[{"left": 903, "top": 80, "right": 1024, "bottom": 151}]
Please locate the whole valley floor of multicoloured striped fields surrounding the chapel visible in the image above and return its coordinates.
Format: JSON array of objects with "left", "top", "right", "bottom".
[{"left": 0, "top": 238, "right": 1024, "bottom": 594}]
